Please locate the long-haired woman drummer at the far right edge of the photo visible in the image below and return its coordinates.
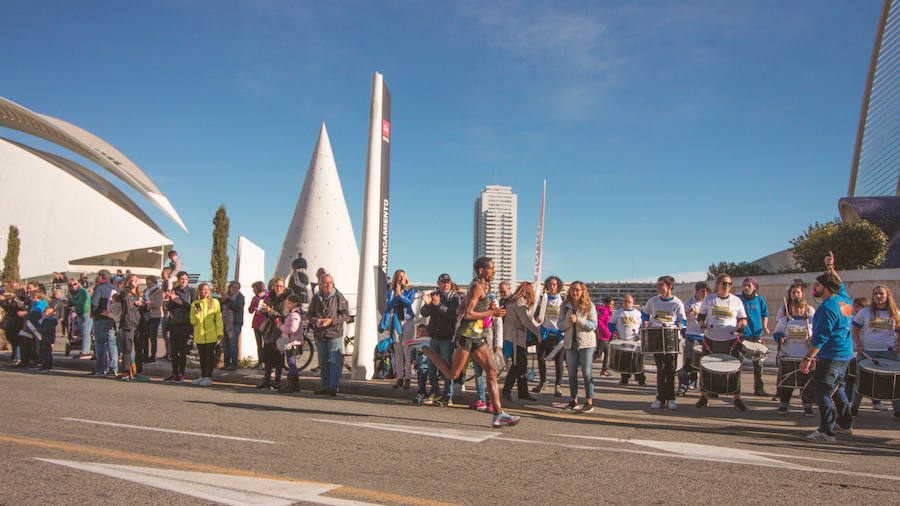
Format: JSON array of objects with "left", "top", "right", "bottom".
[{"left": 850, "top": 285, "right": 900, "bottom": 420}]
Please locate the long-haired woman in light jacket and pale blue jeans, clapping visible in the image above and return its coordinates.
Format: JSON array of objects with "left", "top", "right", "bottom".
[{"left": 559, "top": 281, "right": 597, "bottom": 413}]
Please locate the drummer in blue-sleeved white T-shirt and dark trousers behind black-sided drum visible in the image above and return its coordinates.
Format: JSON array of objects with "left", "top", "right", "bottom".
[{"left": 641, "top": 276, "right": 686, "bottom": 409}]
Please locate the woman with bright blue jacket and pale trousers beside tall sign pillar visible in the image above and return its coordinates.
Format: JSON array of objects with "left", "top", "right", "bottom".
[{"left": 379, "top": 269, "right": 416, "bottom": 390}]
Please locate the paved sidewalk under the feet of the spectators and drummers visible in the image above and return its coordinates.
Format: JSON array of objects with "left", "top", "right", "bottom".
[{"left": 0, "top": 345, "right": 900, "bottom": 446}]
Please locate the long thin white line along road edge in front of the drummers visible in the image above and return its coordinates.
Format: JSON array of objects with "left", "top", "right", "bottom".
[{"left": 497, "top": 434, "right": 900, "bottom": 481}]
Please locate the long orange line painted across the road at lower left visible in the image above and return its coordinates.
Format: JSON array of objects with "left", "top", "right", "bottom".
[{"left": 0, "top": 434, "right": 448, "bottom": 506}]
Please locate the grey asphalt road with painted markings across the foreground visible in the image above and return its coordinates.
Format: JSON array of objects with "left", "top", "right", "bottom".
[{"left": 0, "top": 369, "right": 900, "bottom": 505}]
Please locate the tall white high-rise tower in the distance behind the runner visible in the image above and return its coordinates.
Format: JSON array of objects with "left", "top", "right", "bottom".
[{"left": 472, "top": 185, "right": 518, "bottom": 291}]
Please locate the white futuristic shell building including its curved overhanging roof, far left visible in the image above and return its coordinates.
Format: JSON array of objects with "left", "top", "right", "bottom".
[{"left": 0, "top": 97, "right": 186, "bottom": 279}]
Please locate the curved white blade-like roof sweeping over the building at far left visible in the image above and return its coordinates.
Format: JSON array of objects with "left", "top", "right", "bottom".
[{"left": 0, "top": 97, "right": 187, "bottom": 232}]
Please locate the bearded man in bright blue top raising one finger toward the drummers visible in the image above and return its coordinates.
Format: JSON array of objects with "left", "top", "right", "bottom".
[{"left": 800, "top": 251, "right": 853, "bottom": 443}]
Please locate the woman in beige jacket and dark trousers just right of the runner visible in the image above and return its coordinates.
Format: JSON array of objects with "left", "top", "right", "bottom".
[{"left": 501, "top": 281, "right": 540, "bottom": 401}]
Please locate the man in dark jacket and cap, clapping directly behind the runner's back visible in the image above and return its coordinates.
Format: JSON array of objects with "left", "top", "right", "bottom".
[{"left": 422, "top": 273, "right": 459, "bottom": 404}]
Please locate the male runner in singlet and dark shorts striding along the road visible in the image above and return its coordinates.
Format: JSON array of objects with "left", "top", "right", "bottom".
[{"left": 422, "top": 257, "right": 519, "bottom": 427}]
